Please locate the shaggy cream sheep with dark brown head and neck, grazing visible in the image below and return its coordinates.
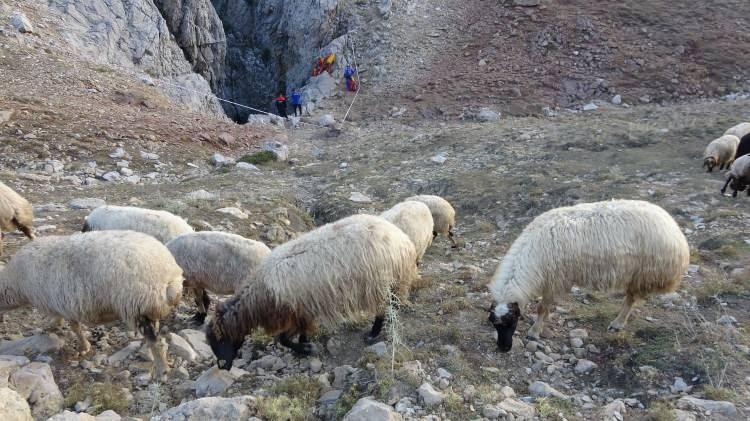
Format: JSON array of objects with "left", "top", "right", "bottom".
[{"left": 206, "top": 215, "right": 418, "bottom": 370}]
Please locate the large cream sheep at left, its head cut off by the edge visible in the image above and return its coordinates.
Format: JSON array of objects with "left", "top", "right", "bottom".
[{"left": 0, "top": 231, "right": 182, "bottom": 377}]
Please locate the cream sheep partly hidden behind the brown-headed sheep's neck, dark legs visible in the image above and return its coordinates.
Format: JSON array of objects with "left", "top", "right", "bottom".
[{"left": 166, "top": 231, "right": 271, "bottom": 324}]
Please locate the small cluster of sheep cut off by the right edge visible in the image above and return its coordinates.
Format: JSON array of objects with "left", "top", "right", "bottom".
[{"left": 703, "top": 123, "right": 750, "bottom": 197}]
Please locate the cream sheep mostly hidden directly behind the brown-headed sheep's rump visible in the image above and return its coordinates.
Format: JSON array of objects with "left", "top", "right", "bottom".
[{"left": 380, "top": 200, "right": 434, "bottom": 262}]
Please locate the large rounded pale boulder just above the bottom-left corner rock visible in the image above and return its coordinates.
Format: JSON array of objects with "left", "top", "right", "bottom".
[{"left": 10, "top": 362, "right": 63, "bottom": 418}]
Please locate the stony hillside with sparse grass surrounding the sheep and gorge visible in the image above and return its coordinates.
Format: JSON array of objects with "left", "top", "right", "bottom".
[{"left": 0, "top": 0, "right": 750, "bottom": 421}]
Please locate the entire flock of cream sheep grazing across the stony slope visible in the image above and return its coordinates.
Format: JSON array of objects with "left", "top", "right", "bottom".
[{"left": 0, "top": 123, "right": 750, "bottom": 378}]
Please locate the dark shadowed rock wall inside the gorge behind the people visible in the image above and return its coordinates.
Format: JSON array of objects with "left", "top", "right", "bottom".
[{"left": 212, "top": 0, "right": 345, "bottom": 121}]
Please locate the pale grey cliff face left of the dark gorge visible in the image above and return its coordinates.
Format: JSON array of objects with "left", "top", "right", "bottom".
[{"left": 48, "top": 0, "right": 222, "bottom": 114}]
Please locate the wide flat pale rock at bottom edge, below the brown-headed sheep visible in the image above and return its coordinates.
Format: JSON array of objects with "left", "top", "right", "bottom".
[{"left": 151, "top": 396, "right": 255, "bottom": 421}]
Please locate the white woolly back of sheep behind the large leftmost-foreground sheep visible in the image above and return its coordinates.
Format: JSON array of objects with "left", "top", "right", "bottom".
[{"left": 82, "top": 206, "right": 193, "bottom": 243}]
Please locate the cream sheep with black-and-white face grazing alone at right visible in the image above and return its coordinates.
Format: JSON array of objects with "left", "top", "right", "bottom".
[{"left": 489, "top": 200, "right": 690, "bottom": 352}]
